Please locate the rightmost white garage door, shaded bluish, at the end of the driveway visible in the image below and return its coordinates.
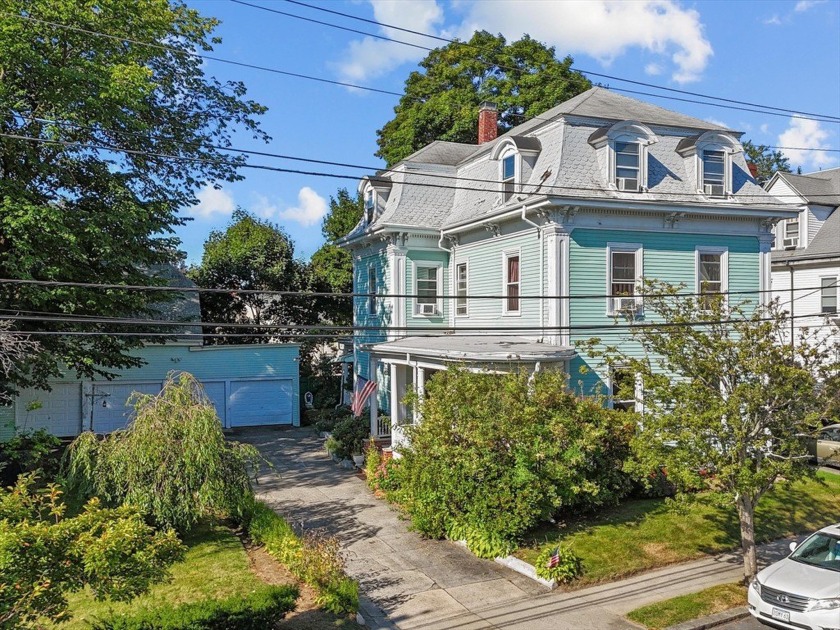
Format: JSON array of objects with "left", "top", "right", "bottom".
[{"left": 228, "top": 379, "right": 294, "bottom": 427}]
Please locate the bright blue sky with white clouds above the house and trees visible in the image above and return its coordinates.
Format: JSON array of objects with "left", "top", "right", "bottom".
[{"left": 178, "top": 0, "right": 840, "bottom": 262}]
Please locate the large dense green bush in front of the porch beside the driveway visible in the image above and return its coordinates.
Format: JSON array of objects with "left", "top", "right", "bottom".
[{"left": 388, "top": 369, "right": 635, "bottom": 553}]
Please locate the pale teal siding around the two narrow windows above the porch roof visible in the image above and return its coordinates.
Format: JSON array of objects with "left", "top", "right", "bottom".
[{"left": 452, "top": 231, "right": 546, "bottom": 331}]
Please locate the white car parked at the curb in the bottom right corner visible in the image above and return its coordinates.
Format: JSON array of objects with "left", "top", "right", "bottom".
[{"left": 747, "top": 524, "right": 840, "bottom": 630}]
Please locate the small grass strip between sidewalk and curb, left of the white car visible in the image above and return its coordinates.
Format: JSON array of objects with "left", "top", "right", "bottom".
[{"left": 627, "top": 584, "right": 747, "bottom": 630}]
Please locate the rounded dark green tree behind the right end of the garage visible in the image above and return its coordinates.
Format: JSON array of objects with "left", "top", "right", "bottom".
[{"left": 189, "top": 209, "right": 315, "bottom": 343}]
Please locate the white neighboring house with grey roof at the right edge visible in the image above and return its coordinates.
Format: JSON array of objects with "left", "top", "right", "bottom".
[{"left": 765, "top": 168, "right": 840, "bottom": 350}]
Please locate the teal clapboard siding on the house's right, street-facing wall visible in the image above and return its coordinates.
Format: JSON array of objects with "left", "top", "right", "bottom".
[{"left": 569, "top": 229, "right": 759, "bottom": 394}]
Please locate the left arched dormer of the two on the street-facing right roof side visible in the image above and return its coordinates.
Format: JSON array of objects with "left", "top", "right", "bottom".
[{"left": 589, "top": 120, "right": 659, "bottom": 192}]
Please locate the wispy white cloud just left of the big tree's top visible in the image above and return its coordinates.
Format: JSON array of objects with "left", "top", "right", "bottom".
[{"left": 334, "top": 0, "right": 443, "bottom": 82}]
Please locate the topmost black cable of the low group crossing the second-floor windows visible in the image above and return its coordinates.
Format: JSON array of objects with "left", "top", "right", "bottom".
[{"left": 0, "top": 278, "right": 833, "bottom": 310}]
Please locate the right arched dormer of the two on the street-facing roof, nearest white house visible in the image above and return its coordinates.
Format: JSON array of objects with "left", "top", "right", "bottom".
[{"left": 677, "top": 131, "right": 743, "bottom": 198}]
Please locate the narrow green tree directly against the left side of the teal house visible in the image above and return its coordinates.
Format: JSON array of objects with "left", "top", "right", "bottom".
[{"left": 310, "top": 188, "right": 364, "bottom": 325}]
